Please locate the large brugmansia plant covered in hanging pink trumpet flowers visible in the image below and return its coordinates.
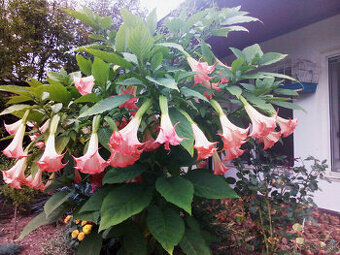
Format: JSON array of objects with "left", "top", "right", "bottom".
[{"left": 0, "top": 4, "right": 298, "bottom": 255}]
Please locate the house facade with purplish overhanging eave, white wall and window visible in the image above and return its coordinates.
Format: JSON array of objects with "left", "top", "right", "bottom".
[{"left": 207, "top": 0, "right": 340, "bottom": 212}]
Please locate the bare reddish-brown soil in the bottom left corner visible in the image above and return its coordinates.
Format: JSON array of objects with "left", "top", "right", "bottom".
[{"left": 0, "top": 215, "right": 58, "bottom": 255}]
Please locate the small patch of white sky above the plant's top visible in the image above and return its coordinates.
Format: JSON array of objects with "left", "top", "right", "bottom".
[{"left": 140, "top": 0, "right": 184, "bottom": 20}]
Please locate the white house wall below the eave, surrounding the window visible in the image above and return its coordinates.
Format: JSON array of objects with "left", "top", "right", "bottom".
[{"left": 226, "top": 15, "right": 340, "bottom": 212}]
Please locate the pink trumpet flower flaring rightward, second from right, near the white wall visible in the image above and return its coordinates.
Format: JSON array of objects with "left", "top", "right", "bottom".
[{"left": 244, "top": 103, "right": 277, "bottom": 138}]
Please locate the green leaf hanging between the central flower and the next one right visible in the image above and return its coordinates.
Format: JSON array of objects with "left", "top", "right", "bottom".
[{"left": 169, "top": 108, "right": 194, "bottom": 156}]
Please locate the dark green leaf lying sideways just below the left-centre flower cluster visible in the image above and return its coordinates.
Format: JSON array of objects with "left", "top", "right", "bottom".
[{"left": 103, "top": 164, "right": 147, "bottom": 184}]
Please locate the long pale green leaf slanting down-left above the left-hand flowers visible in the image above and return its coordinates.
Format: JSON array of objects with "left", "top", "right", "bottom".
[{"left": 78, "top": 95, "right": 132, "bottom": 118}]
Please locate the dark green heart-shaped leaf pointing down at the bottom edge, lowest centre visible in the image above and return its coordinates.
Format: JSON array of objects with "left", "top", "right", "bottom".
[{"left": 146, "top": 206, "right": 185, "bottom": 254}]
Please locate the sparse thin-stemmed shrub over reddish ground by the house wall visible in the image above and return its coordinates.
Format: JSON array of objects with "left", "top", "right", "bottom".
[{"left": 211, "top": 150, "right": 327, "bottom": 254}]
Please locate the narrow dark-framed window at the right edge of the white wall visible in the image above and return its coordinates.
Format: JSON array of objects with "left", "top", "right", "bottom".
[{"left": 328, "top": 56, "right": 340, "bottom": 172}]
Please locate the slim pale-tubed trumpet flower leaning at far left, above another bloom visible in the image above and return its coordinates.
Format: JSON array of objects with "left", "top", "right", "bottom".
[{"left": 2, "top": 120, "right": 27, "bottom": 159}]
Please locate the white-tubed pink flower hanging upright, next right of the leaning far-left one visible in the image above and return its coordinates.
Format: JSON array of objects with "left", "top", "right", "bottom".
[{"left": 36, "top": 133, "right": 66, "bottom": 172}]
